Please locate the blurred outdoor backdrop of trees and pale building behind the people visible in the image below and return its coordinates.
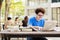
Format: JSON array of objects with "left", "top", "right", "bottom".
[{"left": 0, "top": 0, "right": 60, "bottom": 40}]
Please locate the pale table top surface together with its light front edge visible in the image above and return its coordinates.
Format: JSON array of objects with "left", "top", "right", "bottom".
[{"left": 0, "top": 26, "right": 60, "bottom": 34}]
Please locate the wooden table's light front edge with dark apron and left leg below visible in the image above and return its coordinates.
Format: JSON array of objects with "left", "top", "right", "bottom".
[{"left": 0, "top": 31, "right": 60, "bottom": 40}]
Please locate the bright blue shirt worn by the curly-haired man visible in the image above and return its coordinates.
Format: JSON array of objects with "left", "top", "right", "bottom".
[{"left": 28, "top": 17, "right": 45, "bottom": 27}]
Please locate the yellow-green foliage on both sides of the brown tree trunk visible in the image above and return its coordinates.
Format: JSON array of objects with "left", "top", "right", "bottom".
[{"left": 2, "top": 0, "right": 24, "bottom": 16}]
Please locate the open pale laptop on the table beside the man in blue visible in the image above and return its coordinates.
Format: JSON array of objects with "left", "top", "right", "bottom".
[{"left": 43, "top": 21, "right": 57, "bottom": 30}]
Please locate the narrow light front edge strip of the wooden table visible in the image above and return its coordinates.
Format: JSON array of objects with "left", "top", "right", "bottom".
[{"left": 0, "top": 31, "right": 60, "bottom": 34}]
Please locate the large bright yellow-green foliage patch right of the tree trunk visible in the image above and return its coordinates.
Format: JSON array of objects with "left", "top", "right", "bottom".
[{"left": 9, "top": 0, "right": 24, "bottom": 16}]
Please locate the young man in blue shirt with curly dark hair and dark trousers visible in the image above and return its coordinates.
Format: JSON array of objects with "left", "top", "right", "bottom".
[{"left": 27, "top": 8, "right": 47, "bottom": 40}]
